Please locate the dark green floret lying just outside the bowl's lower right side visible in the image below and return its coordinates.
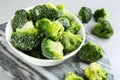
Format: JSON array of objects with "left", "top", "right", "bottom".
[{"left": 78, "top": 42, "right": 103, "bottom": 62}]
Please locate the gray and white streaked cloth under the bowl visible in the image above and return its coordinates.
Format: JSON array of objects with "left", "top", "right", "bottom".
[{"left": 0, "top": 23, "right": 114, "bottom": 80}]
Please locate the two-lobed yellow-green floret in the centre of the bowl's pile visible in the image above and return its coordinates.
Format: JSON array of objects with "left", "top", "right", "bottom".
[{"left": 36, "top": 18, "right": 64, "bottom": 41}]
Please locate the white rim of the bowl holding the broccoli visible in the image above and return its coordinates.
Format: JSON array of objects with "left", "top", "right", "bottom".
[{"left": 5, "top": 4, "right": 85, "bottom": 62}]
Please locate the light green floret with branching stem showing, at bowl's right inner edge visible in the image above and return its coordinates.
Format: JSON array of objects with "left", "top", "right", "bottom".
[{"left": 62, "top": 31, "right": 82, "bottom": 53}]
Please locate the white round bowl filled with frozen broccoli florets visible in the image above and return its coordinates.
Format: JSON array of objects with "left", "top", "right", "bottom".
[{"left": 5, "top": 7, "right": 85, "bottom": 66}]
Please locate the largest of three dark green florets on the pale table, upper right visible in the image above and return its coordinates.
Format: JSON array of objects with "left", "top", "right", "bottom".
[{"left": 93, "top": 18, "right": 113, "bottom": 38}]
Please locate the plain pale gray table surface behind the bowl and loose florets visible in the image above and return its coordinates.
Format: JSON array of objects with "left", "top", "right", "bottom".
[{"left": 0, "top": 0, "right": 120, "bottom": 80}]
